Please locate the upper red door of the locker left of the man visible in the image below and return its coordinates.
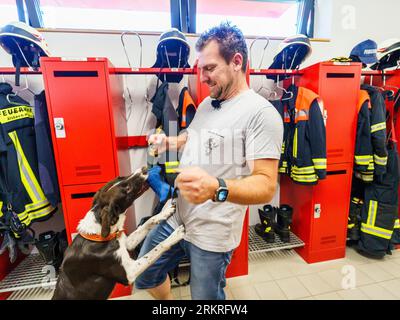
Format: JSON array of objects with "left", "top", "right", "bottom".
[{"left": 45, "top": 61, "right": 116, "bottom": 185}]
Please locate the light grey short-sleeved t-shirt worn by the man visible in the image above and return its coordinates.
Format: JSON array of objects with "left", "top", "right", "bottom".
[{"left": 168, "top": 89, "right": 283, "bottom": 252}]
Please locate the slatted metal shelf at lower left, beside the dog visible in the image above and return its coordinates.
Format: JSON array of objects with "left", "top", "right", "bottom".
[{"left": 0, "top": 253, "right": 57, "bottom": 292}]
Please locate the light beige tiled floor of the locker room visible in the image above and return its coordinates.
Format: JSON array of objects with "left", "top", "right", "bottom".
[{"left": 125, "top": 248, "right": 400, "bottom": 300}]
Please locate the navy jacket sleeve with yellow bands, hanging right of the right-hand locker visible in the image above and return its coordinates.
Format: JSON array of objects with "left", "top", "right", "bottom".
[{"left": 361, "top": 84, "right": 388, "bottom": 176}]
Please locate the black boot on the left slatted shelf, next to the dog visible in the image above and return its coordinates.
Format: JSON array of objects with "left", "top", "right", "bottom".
[{"left": 35, "top": 231, "right": 63, "bottom": 270}]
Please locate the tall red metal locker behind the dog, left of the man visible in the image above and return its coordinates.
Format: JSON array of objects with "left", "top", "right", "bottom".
[{"left": 41, "top": 58, "right": 136, "bottom": 297}]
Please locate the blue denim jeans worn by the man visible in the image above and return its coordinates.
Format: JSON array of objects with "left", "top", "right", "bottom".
[{"left": 135, "top": 221, "right": 233, "bottom": 300}]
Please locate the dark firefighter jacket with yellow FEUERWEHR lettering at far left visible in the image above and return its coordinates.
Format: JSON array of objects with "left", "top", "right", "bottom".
[{"left": 0, "top": 83, "right": 56, "bottom": 230}]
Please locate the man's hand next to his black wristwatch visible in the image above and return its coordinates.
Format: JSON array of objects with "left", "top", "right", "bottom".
[{"left": 175, "top": 167, "right": 219, "bottom": 204}]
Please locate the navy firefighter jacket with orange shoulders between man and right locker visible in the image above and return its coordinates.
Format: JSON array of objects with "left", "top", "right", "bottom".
[{"left": 281, "top": 86, "right": 327, "bottom": 185}]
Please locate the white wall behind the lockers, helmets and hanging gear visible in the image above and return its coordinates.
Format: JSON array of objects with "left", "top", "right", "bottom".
[{"left": 0, "top": 0, "right": 400, "bottom": 229}]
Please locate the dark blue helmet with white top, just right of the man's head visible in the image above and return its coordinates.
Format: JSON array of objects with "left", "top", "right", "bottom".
[{"left": 267, "top": 34, "right": 312, "bottom": 80}]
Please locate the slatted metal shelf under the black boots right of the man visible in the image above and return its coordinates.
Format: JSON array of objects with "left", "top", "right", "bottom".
[{"left": 249, "top": 226, "right": 304, "bottom": 254}]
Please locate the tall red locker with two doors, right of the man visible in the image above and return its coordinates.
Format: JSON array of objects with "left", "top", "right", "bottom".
[{"left": 280, "top": 62, "right": 361, "bottom": 263}]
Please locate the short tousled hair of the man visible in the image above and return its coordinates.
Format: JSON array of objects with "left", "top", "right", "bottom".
[{"left": 196, "top": 22, "right": 247, "bottom": 72}]
